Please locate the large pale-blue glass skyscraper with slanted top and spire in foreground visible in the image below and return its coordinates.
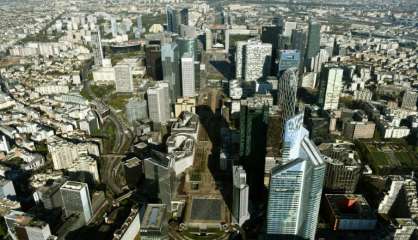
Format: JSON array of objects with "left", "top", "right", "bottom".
[{"left": 267, "top": 117, "right": 326, "bottom": 240}]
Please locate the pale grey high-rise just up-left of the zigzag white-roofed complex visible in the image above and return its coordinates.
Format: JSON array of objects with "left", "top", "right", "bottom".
[{"left": 147, "top": 82, "right": 170, "bottom": 123}]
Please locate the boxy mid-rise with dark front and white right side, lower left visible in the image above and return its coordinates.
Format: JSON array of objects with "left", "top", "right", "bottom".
[{"left": 60, "top": 181, "right": 93, "bottom": 224}]
